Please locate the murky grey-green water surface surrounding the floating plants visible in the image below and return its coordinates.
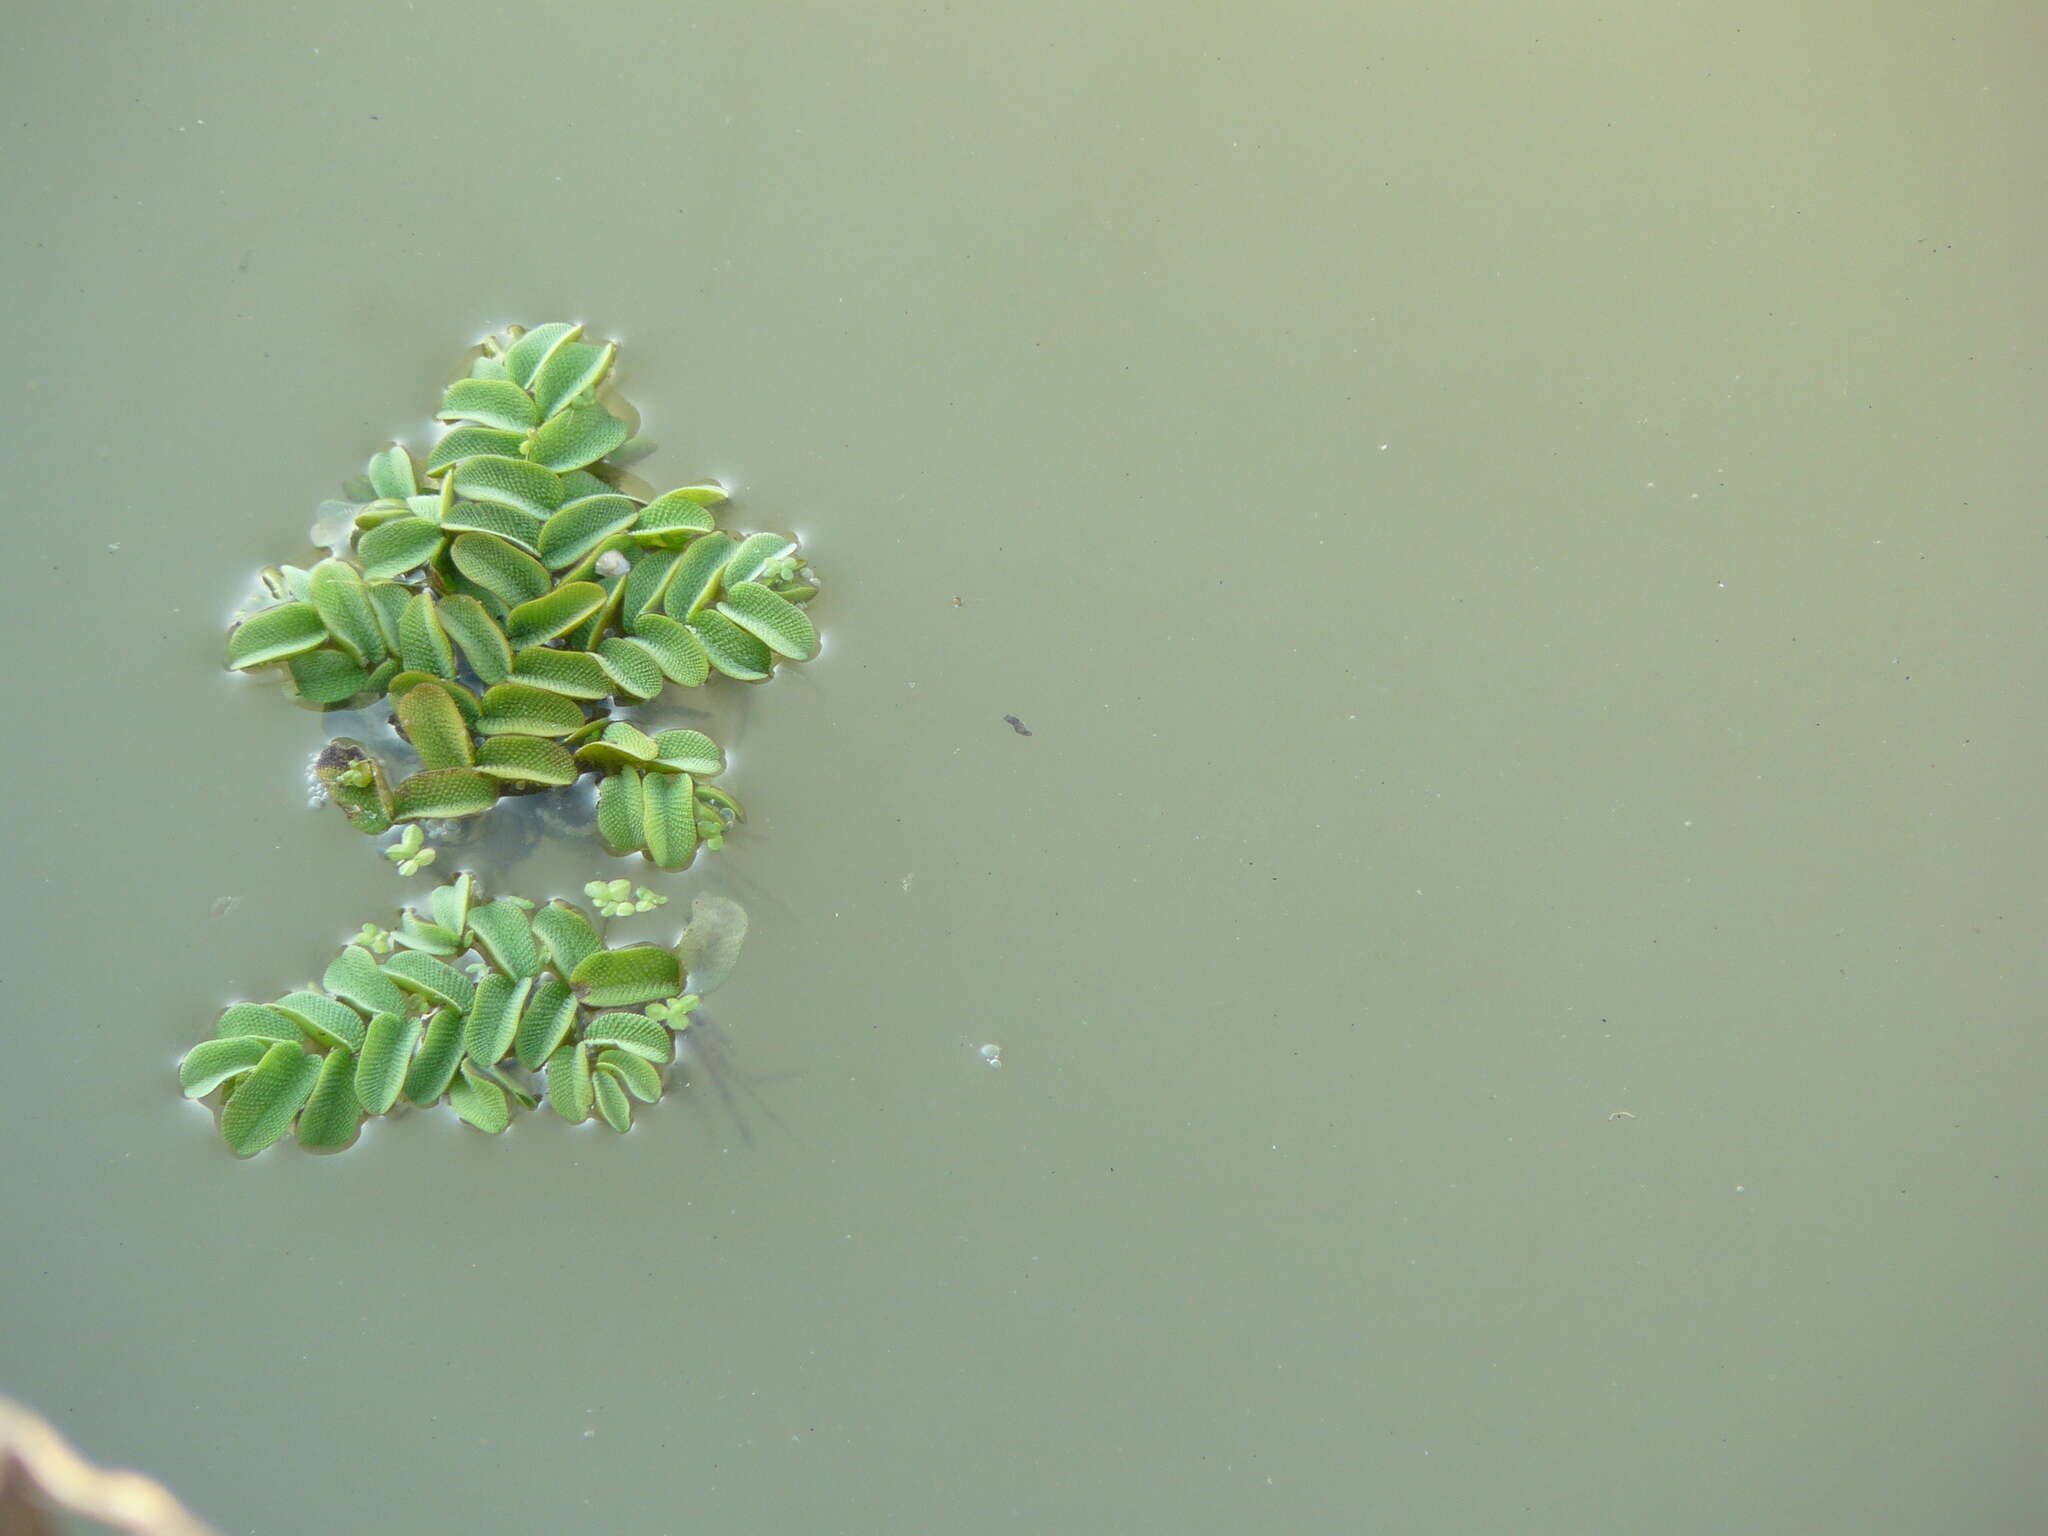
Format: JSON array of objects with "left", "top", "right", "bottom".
[{"left": 0, "top": 2, "right": 2048, "bottom": 1536}]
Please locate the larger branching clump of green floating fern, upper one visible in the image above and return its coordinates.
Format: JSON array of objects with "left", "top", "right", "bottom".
[{"left": 227, "top": 324, "right": 817, "bottom": 870}]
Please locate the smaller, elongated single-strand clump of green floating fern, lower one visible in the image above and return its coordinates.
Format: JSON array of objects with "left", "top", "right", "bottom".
[{"left": 178, "top": 874, "right": 748, "bottom": 1157}]
